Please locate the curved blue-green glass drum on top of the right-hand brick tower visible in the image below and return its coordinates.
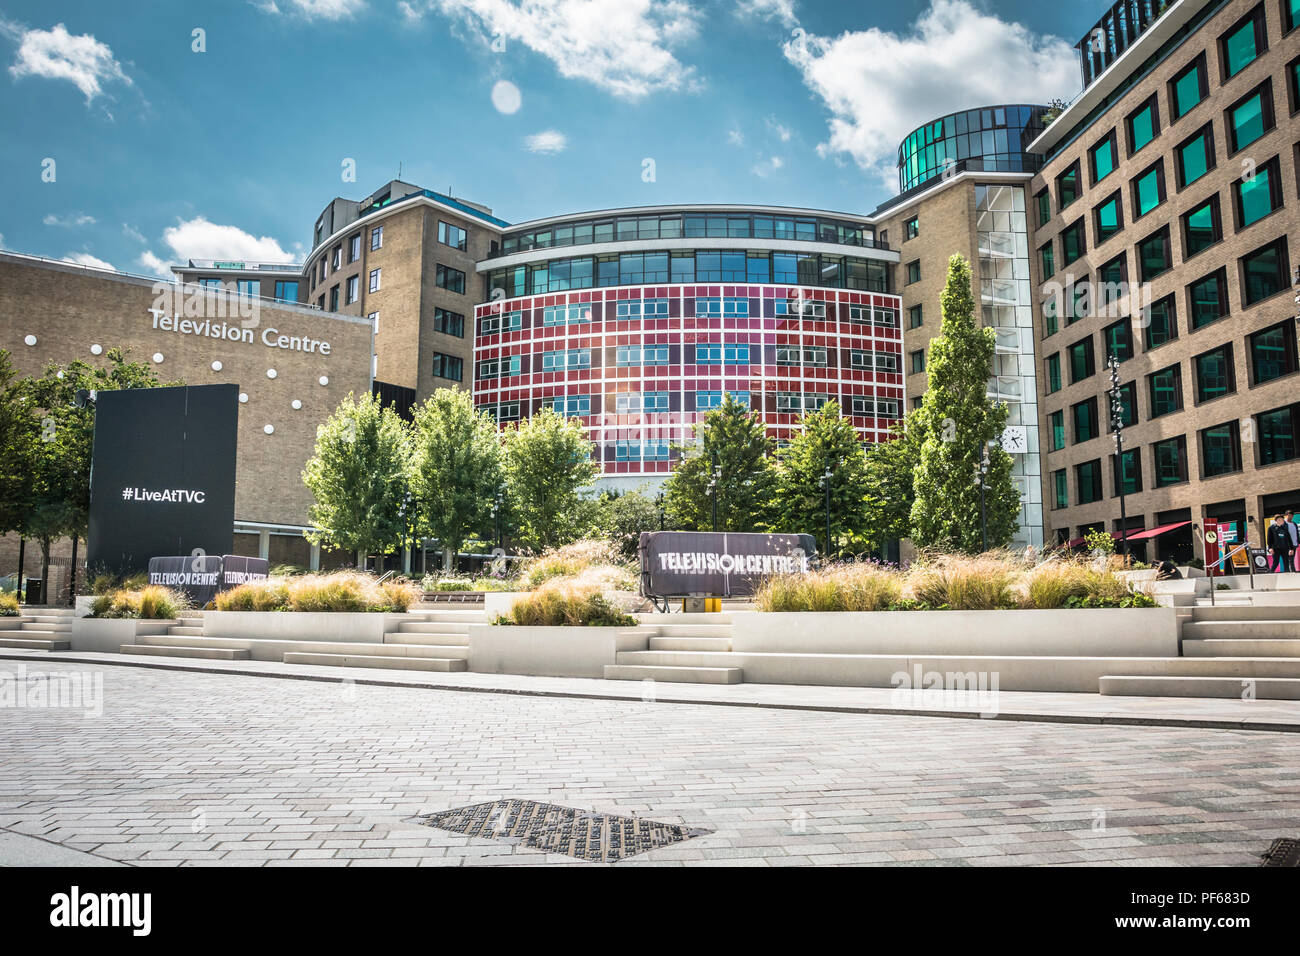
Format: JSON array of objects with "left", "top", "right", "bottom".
[{"left": 898, "top": 104, "right": 1048, "bottom": 193}]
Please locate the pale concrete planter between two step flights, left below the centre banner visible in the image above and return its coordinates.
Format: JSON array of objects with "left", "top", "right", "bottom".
[{"left": 469, "top": 624, "right": 651, "bottom": 678}]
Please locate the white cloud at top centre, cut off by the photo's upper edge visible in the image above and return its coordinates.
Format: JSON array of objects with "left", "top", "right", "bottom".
[{"left": 413, "top": 0, "right": 702, "bottom": 99}]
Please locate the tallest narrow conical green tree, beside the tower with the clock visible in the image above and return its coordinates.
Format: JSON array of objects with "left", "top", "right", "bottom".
[{"left": 911, "top": 255, "right": 1021, "bottom": 553}]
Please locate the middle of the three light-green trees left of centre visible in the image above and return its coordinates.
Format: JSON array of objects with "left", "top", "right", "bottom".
[{"left": 411, "top": 389, "right": 503, "bottom": 571}]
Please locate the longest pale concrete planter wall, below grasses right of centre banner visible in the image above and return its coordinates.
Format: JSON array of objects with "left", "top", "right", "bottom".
[{"left": 732, "top": 607, "right": 1178, "bottom": 657}]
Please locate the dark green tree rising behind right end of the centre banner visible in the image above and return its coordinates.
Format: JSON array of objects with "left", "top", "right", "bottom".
[{"left": 776, "top": 402, "right": 874, "bottom": 557}]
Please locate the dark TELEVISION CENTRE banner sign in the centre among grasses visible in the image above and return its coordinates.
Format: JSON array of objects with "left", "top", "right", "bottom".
[{"left": 640, "top": 531, "right": 816, "bottom": 597}]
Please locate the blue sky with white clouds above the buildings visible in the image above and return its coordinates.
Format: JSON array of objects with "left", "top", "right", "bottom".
[{"left": 0, "top": 0, "right": 1109, "bottom": 276}]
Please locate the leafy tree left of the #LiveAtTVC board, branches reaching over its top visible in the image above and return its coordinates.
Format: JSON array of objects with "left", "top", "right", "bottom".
[{"left": 20, "top": 349, "right": 171, "bottom": 602}]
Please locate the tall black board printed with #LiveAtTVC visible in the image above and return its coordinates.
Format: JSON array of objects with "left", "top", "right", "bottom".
[{"left": 86, "top": 385, "right": 239, "bottom": 575}]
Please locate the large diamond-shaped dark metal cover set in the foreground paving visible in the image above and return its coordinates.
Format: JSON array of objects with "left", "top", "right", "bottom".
[{"left": 416, "top": 800, "right": 712, "bottom": 862}]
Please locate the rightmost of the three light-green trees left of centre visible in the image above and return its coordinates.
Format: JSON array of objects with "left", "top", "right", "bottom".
[{"left": 506, "top": 408, "right": 601, "bottom": 549}]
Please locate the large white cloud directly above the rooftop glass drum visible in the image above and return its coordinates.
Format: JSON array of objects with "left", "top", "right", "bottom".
[{"left": 783, "top": 0, "right": 1079, "bottom": 183}]
